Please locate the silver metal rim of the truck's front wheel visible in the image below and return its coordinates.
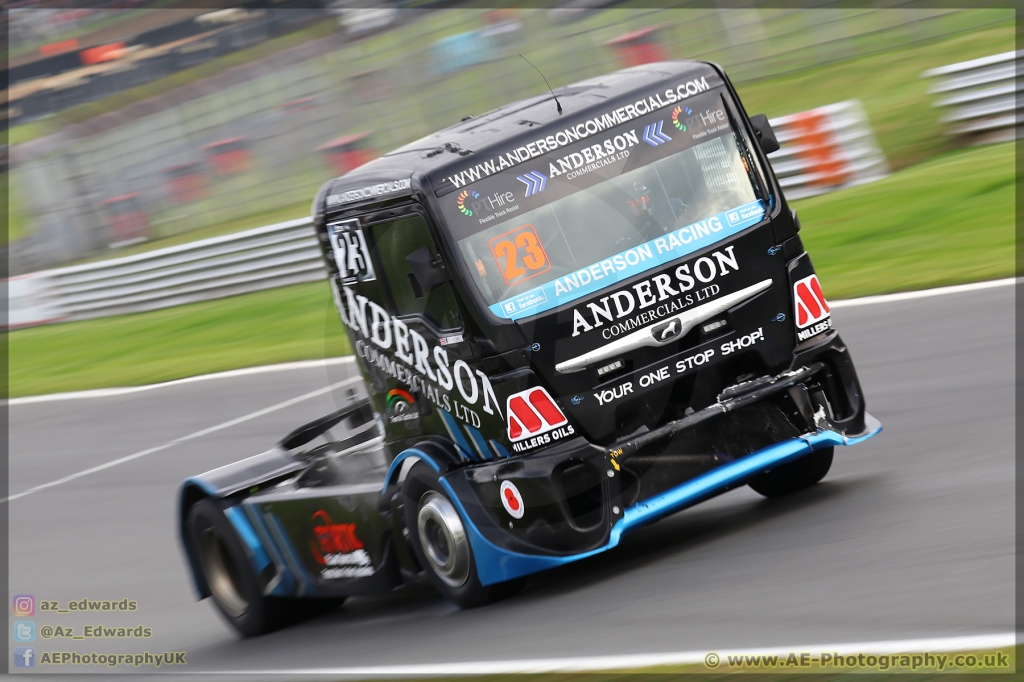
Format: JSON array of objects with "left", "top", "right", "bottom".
[{"left": 416, "top": 491, "right": 470, "bottom": 587}]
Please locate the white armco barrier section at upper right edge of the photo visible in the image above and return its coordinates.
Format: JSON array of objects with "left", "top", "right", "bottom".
[{"left": 921, "top": 50, "right": 1024, "bottom": 144}]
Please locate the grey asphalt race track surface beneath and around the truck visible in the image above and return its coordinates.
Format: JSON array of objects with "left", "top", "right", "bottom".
[{"left": 8, "top": 280, "right": 1015, "bottom": 679}]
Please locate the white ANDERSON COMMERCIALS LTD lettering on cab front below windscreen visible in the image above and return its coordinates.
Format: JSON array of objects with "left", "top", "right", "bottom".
[{"left": 572, "top": 246, "right": 739, "bottom": 341}]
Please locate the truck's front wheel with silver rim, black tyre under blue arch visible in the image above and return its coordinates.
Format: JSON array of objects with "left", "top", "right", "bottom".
[{"left": 402, "top": 464, "right": 526, "bottom": 608}]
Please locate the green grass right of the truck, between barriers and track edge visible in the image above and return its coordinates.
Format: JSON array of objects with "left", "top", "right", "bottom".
[{"left": 795, "top": 142, "right": 1015, "bottom": 298}]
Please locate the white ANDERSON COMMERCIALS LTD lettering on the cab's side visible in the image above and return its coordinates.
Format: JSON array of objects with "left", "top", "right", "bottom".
[{"left": 331, "top": 282, "right": 503, "bottom": 428}]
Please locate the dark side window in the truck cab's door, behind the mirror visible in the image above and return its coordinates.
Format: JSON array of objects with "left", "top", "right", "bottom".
[{"left": 370, "top": 214, "right": 462, "bottom": 330}]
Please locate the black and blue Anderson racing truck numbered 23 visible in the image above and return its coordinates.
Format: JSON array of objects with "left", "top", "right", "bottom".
[{"left": 177, "top": 60, "right": 881, "bottom": 636}]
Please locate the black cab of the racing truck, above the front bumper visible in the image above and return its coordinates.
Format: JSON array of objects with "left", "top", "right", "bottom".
[{"left": 313, "top": 61, "right": 865, "bottom": 493}]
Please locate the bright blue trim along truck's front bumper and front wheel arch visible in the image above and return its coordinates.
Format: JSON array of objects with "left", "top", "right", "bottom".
[{"left": 385, "top": 414, "right": 882, "bottom": 585}]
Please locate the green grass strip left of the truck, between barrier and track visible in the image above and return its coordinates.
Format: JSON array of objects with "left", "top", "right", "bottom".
[{"left": 8, "top": 283, "right": 350, "bottom": 396}]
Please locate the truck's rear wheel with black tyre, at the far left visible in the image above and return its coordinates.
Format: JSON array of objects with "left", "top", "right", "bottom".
[{"left": 186, "top": 500, "right": 344, "bottom": 637}]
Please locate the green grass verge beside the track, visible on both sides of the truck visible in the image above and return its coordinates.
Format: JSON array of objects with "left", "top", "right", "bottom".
[{"left": 9, "top": 143, "right": 1015, "bottom": 396}]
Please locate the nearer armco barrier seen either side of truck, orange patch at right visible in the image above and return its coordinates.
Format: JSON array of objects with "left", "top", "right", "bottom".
[{"left": 8, "top": 101, "right": 888, "bottom": 327}]
